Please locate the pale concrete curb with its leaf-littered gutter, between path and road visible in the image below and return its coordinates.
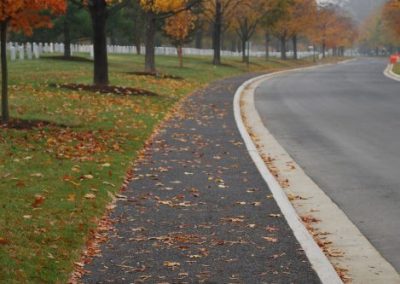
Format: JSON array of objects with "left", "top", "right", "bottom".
[{"left": 234, "top": 62, "right": 400, "bottom": 284}]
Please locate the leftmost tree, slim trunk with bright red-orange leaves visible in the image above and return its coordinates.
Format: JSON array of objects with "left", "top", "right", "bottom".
[{"left": 0, "top": 0, "right": 65, "bottom": 123}]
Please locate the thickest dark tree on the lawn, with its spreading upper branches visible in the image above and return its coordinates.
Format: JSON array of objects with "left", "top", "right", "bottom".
[{"left": 71, "top": 0, "right": 130, "bottom": 86}]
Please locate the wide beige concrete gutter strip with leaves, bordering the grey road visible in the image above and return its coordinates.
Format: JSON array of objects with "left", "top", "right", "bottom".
[{"left": 236, "top": 67, "right": 400, "bottom": 283}]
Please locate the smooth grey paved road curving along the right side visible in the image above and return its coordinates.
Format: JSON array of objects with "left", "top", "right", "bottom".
[{"left": 255, "top": 59, "right": 400, "bottom": 271}]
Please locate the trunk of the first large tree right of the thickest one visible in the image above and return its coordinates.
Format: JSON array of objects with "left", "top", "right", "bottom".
[{"left": 144, "top": 12, "right": 157, "bottom": 73}]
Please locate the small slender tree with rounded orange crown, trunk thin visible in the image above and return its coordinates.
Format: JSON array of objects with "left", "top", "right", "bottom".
[{"left": 164, "top": 11, "right": 196, "bottom": 67}]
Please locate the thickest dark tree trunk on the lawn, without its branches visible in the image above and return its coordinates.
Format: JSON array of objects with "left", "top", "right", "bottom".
[{"left": 90, "top": 1, "right": 109, "bottom": 86}]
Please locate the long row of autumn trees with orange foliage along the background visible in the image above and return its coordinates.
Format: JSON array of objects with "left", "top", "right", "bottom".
[{"left": 0, "top": 0, "right": 356, "bottom": 121}]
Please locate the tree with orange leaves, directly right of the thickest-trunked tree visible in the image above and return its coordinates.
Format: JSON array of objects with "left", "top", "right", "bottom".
[{"left": 140, "top": 0, "right": 201, "bottom": 73}]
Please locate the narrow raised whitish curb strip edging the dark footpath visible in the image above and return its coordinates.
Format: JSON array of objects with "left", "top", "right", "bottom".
[{"left": 233, "top": 64, "right": 343, "bottom": 284}]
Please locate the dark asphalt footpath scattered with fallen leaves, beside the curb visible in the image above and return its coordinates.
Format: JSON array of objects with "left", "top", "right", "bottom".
[{"left": 83, "top": 76, "right": 319, "bottom": 283}]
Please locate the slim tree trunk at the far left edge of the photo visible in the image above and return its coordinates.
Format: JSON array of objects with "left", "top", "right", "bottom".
[{"left": 0, "top": 22, "right": 10, "bottom": 123}]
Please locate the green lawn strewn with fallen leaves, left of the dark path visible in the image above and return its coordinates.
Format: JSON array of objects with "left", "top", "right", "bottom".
[{"left": 0, "top": 52, "right": 324, "bottom": 283}]
